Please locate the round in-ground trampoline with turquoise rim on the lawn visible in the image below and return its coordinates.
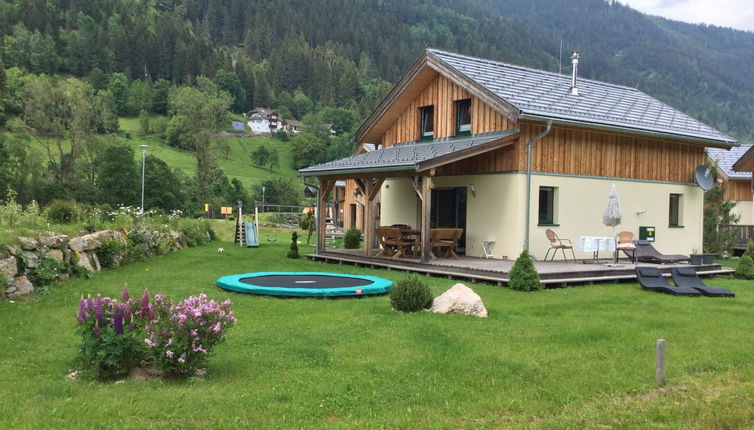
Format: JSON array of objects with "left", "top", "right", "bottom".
[{"left": 217, "top": 272, "right": 393, "bottom": 297}]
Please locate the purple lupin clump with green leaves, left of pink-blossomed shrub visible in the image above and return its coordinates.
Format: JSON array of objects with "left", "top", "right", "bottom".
[{"left": 76, "top": 287, "right": 148, "bottom": 380}]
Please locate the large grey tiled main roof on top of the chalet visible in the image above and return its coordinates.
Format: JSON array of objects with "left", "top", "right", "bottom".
[{"left": 428, "top": 49, "right": 736, "bottom": 143}]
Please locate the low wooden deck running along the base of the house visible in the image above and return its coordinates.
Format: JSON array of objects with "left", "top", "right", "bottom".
[{"left": 306, "top": 249, "right": 734, "bottom": 287}]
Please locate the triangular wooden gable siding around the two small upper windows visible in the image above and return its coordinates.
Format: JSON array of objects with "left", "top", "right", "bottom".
[{"left": 380, "top": 74, "right": 515, "bottom": 147}]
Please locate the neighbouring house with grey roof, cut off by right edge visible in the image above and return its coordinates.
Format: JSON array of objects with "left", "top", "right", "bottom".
[{"left": 707, "top": 145, "right": 754, "bottom": 225}]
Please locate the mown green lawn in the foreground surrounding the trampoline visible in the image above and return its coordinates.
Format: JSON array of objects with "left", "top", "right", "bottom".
[{"left": 0, "top": 228, "right": 754, "bottom": 429}]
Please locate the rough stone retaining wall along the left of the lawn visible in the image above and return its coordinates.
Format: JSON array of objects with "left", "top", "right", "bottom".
[{"left": 0, "top": 228, "right": 188, "bottom": 299}]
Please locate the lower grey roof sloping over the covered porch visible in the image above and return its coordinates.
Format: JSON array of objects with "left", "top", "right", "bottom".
[{"left": 299, "top": 129, "right": 519, "bottom": 176}]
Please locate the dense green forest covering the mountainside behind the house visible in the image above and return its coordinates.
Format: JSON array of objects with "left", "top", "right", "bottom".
[{"left": 0, "top": 0, "right": 754, "bottom": 210}]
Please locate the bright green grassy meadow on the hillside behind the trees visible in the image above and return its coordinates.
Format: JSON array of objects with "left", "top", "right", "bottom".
[{"left": 120, "top": 118, "right": 296, "bottom": 190}]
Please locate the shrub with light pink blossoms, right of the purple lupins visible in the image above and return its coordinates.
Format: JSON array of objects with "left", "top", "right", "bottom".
[{"left": 144, "top": 294, "right": 237, "bottom": 375}]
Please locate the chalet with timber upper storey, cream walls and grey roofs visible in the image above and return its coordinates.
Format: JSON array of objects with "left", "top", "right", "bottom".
[{"left": 300, "top": 49, "right": 736, "bottom": 262}]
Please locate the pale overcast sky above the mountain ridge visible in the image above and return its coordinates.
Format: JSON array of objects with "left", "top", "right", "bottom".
[{"left": 619, "top": 0, "right": 754, "bottom": 31}]
